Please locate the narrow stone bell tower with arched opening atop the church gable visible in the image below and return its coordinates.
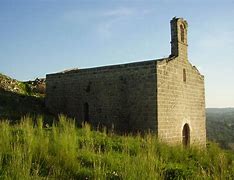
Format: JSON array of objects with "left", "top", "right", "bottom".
[{"left": 171, "top": 17, "right": 188, "bottom": 60}]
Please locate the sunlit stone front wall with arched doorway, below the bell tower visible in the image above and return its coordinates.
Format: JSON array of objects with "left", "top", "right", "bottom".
[{"left": 157, "top": 56, "right": 206, "bottom": 146}]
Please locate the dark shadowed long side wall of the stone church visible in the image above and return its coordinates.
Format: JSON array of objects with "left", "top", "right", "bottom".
[{"left": 46, "top": 61, "right": 157, "bottom": 132}]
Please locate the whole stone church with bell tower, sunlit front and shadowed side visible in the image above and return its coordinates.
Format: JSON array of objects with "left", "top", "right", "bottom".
[{"left": 46, "top": 18, "right": 206, "bottom": 146}]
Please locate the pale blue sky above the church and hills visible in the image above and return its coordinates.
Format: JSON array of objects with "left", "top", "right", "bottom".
[{"left": 0, "top": 0, "right": 234, "bottom": 107}]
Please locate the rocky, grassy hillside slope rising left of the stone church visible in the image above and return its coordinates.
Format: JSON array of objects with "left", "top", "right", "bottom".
[{"left": 0, "top": 74, "right": 46, "bottom": 120}]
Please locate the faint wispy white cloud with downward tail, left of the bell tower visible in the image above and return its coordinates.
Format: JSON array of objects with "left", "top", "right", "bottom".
[{"left": 63, "top": 7, "right": 152, "bottom": 38}]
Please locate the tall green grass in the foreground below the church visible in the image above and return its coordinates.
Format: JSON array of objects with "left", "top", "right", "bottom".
[{"left": 0, "top": 116, "right": 234, "bottom": 180}]
